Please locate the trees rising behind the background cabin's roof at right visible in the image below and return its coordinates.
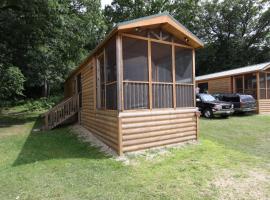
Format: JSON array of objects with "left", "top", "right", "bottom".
[{"left": 197, "top": 0, "right": 270, "bottom": 74}]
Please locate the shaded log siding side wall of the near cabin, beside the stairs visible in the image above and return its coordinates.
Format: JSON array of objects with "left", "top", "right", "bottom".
[{"left": 65, "top": 61, "right": 119, "bottom": 151}]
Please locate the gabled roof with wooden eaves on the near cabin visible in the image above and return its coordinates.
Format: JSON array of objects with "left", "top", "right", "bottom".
[{"left": 68, "top": 12, "right": 204, "bottom": 78}]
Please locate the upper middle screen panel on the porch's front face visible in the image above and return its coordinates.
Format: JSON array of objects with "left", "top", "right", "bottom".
[{"left": 151, "top": 42, "right": 172, "bottom": 82}]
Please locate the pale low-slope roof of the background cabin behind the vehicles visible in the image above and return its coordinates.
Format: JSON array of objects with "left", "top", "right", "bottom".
[{"left": 196, "top": 62, "right": 270, "bottom": 81}]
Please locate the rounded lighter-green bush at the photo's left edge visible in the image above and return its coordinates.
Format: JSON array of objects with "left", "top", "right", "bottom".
[{"left": 0, "top": 64, "right": 25, "bottom": 102}]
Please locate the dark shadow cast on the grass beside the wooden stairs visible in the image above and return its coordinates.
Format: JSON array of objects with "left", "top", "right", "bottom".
[{"left": 13, "top": 115, "right": 108, "bottom": 166}]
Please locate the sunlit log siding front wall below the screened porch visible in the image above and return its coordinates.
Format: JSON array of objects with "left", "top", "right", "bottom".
[{"left": 119, "top": 109, "right": 197, "bottom": 152}]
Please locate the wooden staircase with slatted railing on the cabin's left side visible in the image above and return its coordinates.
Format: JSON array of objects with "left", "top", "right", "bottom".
[{"left": 42, "top": 94, "right": 80, "bottom": 130}]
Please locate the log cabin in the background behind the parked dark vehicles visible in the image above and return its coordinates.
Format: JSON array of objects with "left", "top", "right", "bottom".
[{"left": 196, "top": 62, "right": 270, "bottom": 114}]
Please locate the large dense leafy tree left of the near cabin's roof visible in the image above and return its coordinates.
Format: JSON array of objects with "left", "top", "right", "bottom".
[{"left": 0, "top": 0, "right": 106, "bottom": 96}]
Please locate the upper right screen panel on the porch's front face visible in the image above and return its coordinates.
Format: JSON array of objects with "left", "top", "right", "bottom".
[{"left": 175, "top": 46, "right": 193, "bottom": 83}]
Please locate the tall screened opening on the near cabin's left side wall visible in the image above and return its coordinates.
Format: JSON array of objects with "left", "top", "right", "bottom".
[{"left": 97, "top": 38, "right": 117, "bottom": 110}]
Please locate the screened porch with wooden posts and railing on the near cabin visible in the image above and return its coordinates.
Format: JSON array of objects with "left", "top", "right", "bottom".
[{"left": 96, "top": 28, "right": 195, "bottom": 111}]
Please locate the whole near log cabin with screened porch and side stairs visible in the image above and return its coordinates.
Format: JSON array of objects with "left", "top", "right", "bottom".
[{"left": 46, "top": 13, "right": 203, "bottom": 155}]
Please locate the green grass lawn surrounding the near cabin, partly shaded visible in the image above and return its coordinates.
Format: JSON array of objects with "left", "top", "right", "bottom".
[{"left": 0, "top": 109, "right": 270, "bottom": 200}]
